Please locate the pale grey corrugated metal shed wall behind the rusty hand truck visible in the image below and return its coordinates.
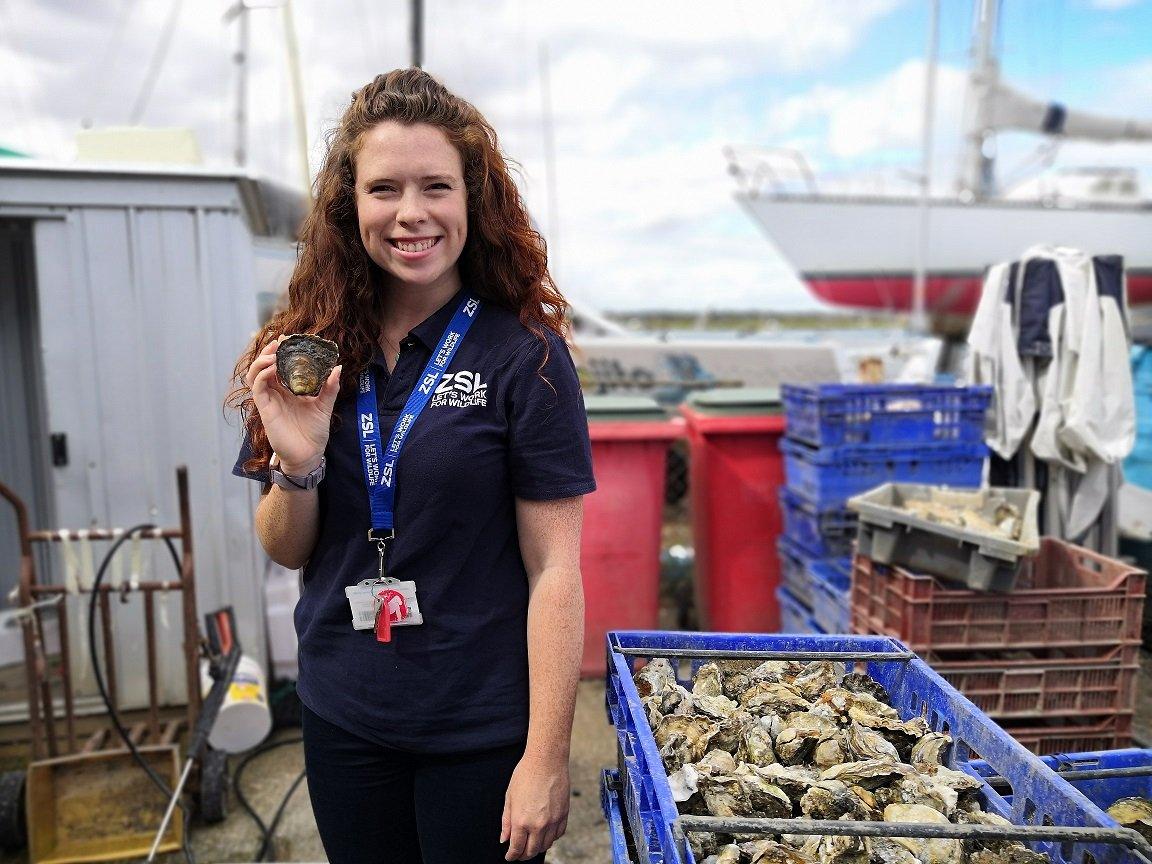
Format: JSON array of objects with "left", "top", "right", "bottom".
[{"left": 8, "top": 172, "right": 265, "bottom": 706}]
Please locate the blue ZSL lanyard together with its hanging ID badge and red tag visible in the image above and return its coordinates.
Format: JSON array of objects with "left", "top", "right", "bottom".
[{"left": 344, "top": 297, "right": 480, "bottom": 642}]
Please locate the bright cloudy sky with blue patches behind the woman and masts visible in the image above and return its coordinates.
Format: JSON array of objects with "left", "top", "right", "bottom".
[{"left": 0, "top": 0, "right": 1152, "bottom": 310}]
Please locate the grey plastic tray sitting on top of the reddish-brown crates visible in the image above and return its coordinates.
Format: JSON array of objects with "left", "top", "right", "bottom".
[{"left": 848, "top": 483, "right": 1040, "bottom": 591}]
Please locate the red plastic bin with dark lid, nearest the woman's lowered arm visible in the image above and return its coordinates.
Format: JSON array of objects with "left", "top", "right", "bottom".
[{"left": 581, "top": 396, "right": 684, "bottom": 677}]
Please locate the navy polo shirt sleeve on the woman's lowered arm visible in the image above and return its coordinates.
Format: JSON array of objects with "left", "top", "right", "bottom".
[{"left": 507, "top": 331, "right": 596, "bottom": 501}]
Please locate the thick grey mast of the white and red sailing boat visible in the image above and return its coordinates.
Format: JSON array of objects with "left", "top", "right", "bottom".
[{"left": 960, "top": 0, "right": 1000, "bottom": 200}]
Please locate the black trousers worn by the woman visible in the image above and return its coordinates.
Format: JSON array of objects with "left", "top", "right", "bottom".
[{"left": 302, "top": 706, "right": 544, "bottom": 864}]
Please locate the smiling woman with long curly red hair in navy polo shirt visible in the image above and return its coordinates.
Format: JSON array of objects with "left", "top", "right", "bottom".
[{"left": 233, "top": 69, "right": 594, "bottom": 864}]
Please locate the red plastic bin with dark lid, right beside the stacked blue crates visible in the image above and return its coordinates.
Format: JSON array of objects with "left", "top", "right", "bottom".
[{"left": 681, "top": 388, "right": 785, "bottom": 632}]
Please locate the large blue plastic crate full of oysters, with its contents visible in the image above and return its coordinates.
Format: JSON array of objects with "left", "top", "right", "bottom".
[{"left": 606, "top": 631, "right": 1152, "bottom": 864}]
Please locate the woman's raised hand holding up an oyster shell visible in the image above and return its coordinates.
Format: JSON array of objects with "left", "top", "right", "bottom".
[{"left": 244, "top": 334, "right": 341, "bottom": 476}]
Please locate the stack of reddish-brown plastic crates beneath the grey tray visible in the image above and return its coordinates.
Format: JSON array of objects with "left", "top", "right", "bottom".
[{"left": 851, "top": 537, "right": 1146, "bottom": 753}]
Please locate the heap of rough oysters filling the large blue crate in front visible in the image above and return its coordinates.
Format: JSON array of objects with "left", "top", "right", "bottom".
[{"left": 635, "top": 660, "right": 1055, "bottom": 864}]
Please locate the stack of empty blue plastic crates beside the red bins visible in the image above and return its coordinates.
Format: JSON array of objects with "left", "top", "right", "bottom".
[{"left": 776, "top": 384, "right": 992, "bottom": 634}]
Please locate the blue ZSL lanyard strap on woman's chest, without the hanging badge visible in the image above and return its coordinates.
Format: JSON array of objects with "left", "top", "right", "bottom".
[{"left": 356, "top": 297, "right": 480, "bottom": 541}]
